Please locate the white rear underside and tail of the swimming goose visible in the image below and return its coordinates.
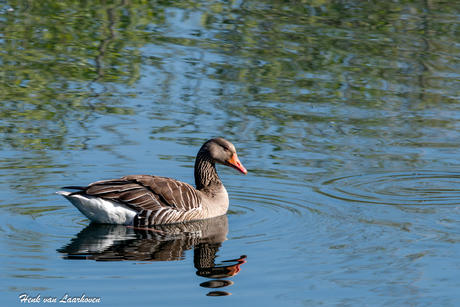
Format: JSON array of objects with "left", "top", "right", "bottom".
[{"left": 56, "top": 191, "right": 137, "bottom": 225}]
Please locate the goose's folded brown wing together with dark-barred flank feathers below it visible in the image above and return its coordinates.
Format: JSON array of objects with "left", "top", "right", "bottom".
[{"left": 70, "top": 175, "right": 203, "bottom": 227}]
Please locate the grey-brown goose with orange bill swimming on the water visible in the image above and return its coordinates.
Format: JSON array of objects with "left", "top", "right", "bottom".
[{"left": 57, "top": 138, "right": 247, "bottom": 227}]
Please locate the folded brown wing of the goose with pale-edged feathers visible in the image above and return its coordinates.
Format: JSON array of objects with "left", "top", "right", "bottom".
[{"left": 76, "top": 175, "right": 201, "bottom": 212}]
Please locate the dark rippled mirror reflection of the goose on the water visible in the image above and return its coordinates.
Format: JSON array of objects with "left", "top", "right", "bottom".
[{"left": 58, "top": 215, "right": 246, "bottom": 296}]
